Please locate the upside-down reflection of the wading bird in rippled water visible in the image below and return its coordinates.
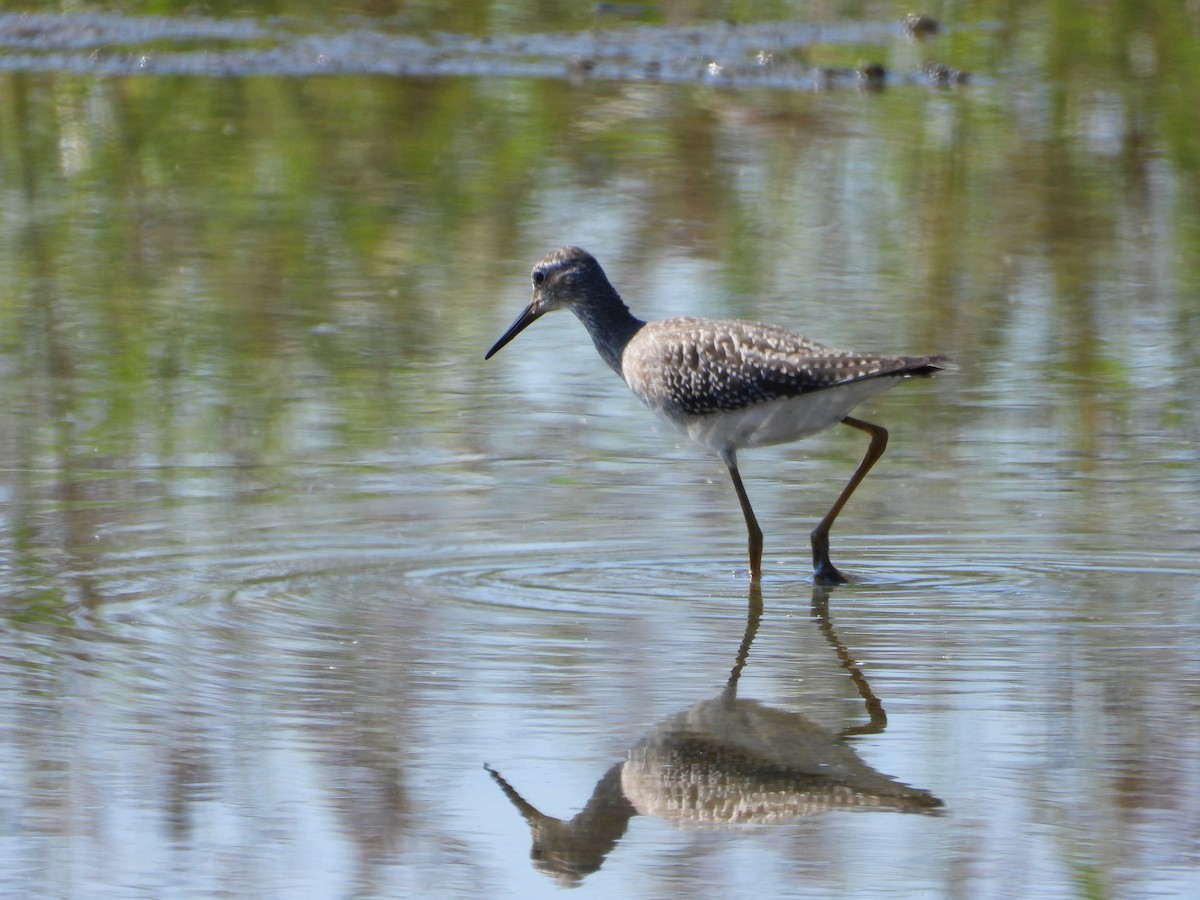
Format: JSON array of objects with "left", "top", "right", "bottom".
[{"left": 485, "top": 583, "right": 942, "bottom": 886}]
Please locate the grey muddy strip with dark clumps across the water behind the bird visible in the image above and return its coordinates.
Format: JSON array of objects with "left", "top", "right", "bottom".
[{"left": 0, "top": 13, "right": 965, "bottom": 90}]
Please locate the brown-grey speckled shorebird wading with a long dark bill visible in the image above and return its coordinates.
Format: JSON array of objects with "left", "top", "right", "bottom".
[{"left": 484, "top": 247, "right": 946, "bottom": 584}]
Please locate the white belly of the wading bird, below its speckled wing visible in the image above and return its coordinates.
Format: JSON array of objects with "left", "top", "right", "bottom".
[{"left": 655, "top": 378, "right": 901, "bottom": 454}]
